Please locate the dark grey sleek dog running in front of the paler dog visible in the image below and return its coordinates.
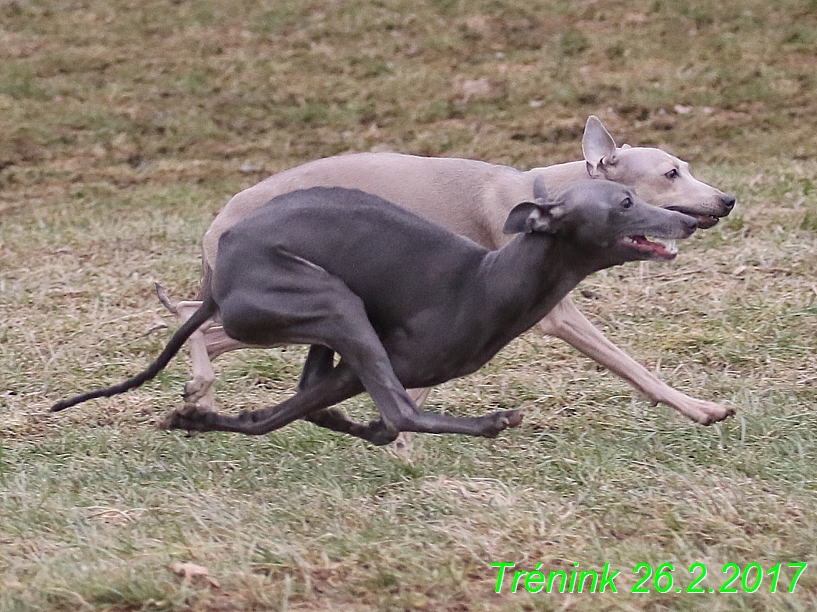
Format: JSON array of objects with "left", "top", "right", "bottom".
[{"left": 52, "top": 180, "right": 697, "bottom": 444}]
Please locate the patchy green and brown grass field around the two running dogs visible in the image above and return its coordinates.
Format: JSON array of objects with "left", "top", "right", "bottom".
[{"left": 0, "top": 0, "right": 817, "bottom": 612}]
